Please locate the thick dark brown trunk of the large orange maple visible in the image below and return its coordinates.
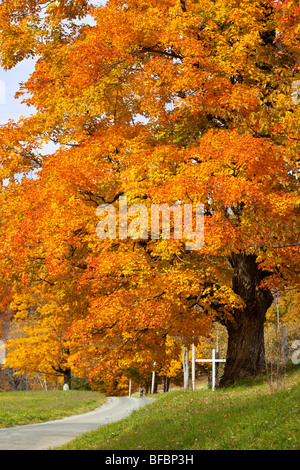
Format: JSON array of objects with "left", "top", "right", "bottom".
[{"left": 220, "top": 254, "right": 273, "bottom": 386}]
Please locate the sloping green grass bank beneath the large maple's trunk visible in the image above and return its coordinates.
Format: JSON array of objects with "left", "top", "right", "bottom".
[{"left": 59, "top": 367, "right": 300, "bottom": 450}]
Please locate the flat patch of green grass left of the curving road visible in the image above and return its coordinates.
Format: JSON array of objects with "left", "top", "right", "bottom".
[{"left": 0, "top": 390, "right": 106, "bottom": 428}]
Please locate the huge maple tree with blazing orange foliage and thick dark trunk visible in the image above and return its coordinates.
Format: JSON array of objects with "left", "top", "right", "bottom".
[{"left": 0, "top": 0, "right": 300, "bottom": 385}]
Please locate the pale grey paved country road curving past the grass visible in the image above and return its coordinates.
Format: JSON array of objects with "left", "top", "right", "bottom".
[{"left": 0, "top": 397, "right": 152, "bottom": 450}]
